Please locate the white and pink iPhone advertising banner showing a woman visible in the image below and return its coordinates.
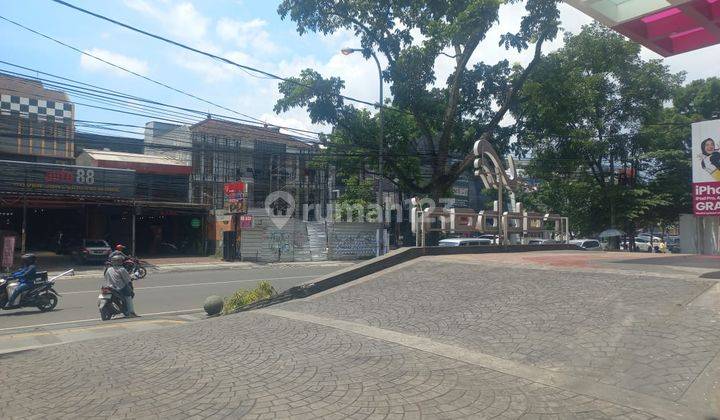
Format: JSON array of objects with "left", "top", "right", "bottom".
[{"left": 692, "top": 120, "right": 720, "bottom": 216}]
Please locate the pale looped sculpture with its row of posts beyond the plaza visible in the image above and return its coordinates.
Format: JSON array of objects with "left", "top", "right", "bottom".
[{"left": 411, "top": 140, "right": 570, "bottom": 246}]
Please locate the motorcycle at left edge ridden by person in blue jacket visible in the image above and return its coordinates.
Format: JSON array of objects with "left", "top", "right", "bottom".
[{"left": 0, "top": 269, "right": 75, "bottom": 312}]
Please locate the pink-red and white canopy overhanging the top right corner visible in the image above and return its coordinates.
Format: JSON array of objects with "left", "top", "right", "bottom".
[{"left": 565, "top": 0, "right": 720, "bottom": 57}]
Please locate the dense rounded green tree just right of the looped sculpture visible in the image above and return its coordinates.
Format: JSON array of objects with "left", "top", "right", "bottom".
[{"left": 513, "top": 24, "right": 683, "bottom": 233}]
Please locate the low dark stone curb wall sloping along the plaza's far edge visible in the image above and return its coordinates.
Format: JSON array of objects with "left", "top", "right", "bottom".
[{"left": 236, "top": 244, "right": 584, "bottom": 312}]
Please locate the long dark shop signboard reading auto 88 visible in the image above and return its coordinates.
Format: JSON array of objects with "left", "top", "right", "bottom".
[{"left": 0, "top": 160, "right": 135, "bottom": 199}]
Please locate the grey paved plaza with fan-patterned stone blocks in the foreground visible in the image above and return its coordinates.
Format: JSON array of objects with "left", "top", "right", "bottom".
[{"left": 0, "top": 252, "right": 720, "bottom": 419}]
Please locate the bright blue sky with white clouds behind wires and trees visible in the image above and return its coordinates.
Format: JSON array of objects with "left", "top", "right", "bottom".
[{"left": 0, "top": 0, "right": 720, "bottom": 139}]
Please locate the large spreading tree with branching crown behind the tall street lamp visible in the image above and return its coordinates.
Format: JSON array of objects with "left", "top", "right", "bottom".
[{"left": 275, "top": 0, "right": 558, "bottom": 198}]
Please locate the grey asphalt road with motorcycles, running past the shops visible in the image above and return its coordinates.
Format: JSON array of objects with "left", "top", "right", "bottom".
[{"left": 0, "top": 266, "right": 341, "bottom": 333}]
